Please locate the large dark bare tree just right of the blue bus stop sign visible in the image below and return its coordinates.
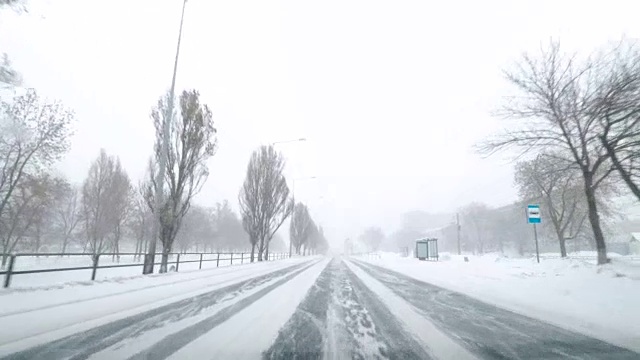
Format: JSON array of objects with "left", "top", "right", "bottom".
[{"left": 481, "top": 42, "right": 638, "bottom": 264}]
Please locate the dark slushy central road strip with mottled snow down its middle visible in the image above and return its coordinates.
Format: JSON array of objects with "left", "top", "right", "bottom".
[{"left": 263, "top": 259, "right": 429, "bottom": 360}]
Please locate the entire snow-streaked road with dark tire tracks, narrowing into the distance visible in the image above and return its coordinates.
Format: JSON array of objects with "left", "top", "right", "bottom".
[{"left": 0, "top": 258, "right": 640, "bottom": 360}]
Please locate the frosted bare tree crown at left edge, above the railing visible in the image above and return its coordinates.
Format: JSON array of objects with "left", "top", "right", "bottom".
[{"left": 0, "top": 90, "right": 74, "bottom": 236}]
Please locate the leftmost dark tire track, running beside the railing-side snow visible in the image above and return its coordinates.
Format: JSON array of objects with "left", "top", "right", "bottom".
[{"left": 2, "top": 262, "right": 315, "bottom": 360}]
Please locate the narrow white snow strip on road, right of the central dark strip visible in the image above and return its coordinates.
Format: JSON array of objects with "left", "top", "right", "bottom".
[{"left": 346, "top": 261, "right": 476, "bottom": 360}]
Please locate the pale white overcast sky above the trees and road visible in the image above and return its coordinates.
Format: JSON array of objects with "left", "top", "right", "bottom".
[{"left": 0, "top": 0, "right": 640, "bottom": 243}]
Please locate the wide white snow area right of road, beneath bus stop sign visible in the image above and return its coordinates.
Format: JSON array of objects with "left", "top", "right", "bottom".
[{"left": 359, "top": 253, "right": 640, "bottom": 351}]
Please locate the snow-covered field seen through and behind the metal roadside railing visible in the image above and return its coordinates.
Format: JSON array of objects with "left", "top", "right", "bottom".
[{"left": 0, "top": 253, "right": 262, "bottom": 291}]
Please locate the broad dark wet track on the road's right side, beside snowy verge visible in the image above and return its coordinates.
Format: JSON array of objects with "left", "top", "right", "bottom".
[{"left": 351, "top": 260, "right": 640, "bottom": 360}]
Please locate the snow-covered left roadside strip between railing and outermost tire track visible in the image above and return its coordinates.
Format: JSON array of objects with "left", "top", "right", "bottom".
[{"left": 0, "top": 258, "right": 312, "bottom": 353}]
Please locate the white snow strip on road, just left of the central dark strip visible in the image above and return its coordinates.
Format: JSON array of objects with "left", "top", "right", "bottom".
[{"left": 169, "top": 259, "right": 330, "bottom": 360}]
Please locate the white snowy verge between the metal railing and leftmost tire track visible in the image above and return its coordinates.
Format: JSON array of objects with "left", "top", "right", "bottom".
[{"left": 0, "top": 258, "right": 310, "bottom": 355}]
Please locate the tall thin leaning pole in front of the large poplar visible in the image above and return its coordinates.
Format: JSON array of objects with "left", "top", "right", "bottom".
[{"left": 142, "top": 0, "right": 187, "bottom": 274}]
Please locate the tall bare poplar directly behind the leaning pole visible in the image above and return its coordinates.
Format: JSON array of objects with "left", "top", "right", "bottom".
[{"left": 146, "top": 90, "right": 216, "bottom": 273}]
